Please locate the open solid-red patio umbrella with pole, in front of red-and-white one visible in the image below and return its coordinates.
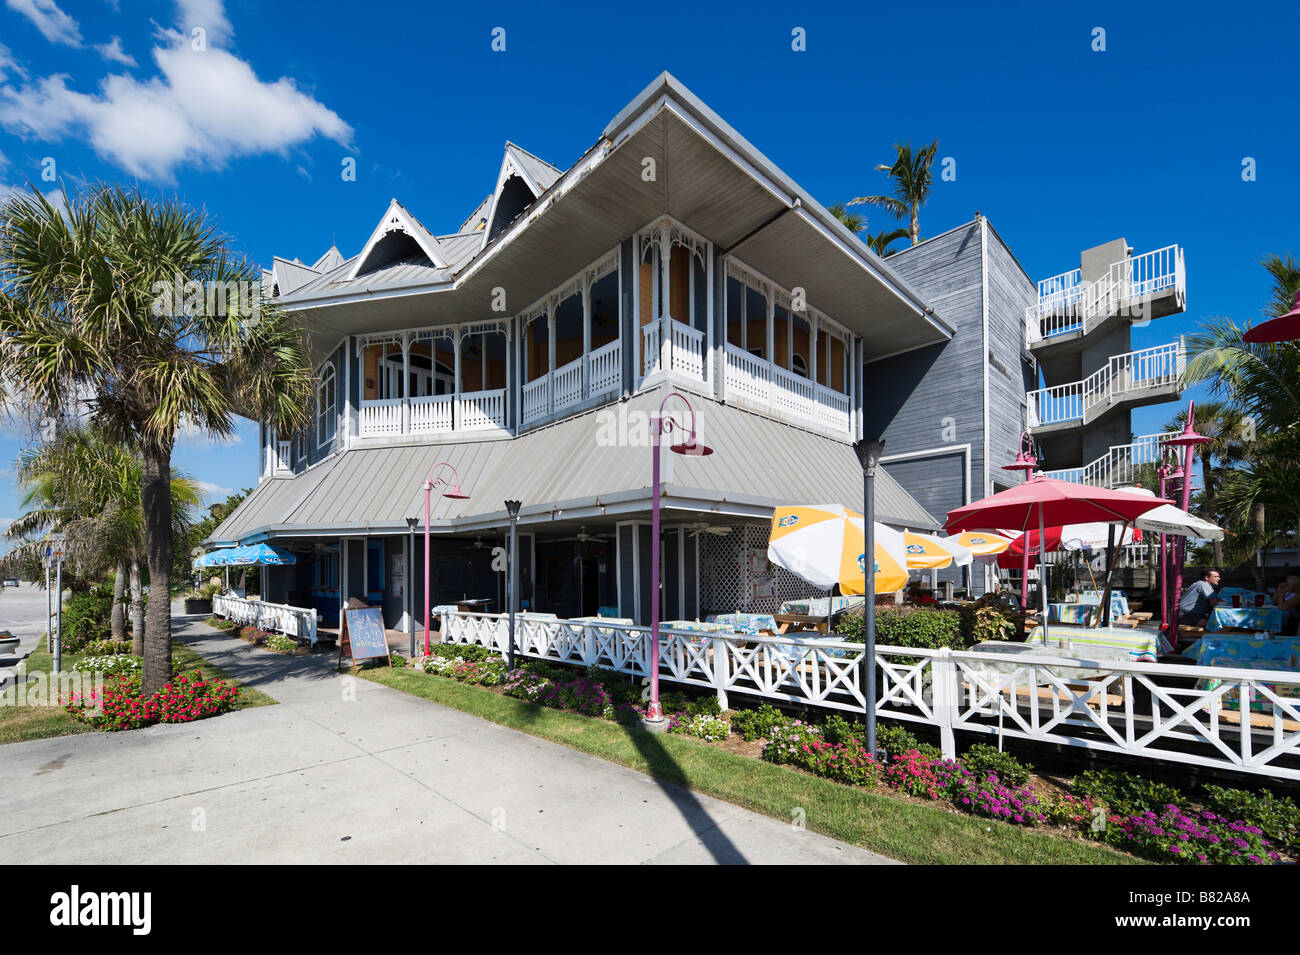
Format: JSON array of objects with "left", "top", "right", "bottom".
[{"left": 944, "top": 474, "right": 1173, "bottom": 641}]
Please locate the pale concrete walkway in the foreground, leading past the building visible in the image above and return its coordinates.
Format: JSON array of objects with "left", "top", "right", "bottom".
[{"left": 0, "top": 617, "right": 889, "bottom": 864}]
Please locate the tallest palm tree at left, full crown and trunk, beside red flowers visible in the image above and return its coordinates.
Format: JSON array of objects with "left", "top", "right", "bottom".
[{"left": 0, "top": 186, "right": 312, "bottom": 694}]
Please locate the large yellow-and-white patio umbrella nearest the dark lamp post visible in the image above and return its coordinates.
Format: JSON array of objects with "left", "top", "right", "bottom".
[{"left": 767, "top": 504, "right": 907, "bottom": 594}]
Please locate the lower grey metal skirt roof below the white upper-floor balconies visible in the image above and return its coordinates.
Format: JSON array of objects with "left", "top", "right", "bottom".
[{"left": 211, "top": 387, "right": 939, "bottom": 542}]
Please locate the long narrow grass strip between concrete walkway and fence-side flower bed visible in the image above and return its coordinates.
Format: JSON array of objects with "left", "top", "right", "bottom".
[{"left": 361, "top": 667, "right": 1141, "bottom": 864}]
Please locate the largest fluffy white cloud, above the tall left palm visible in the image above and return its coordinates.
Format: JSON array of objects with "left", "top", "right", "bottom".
[{"left": 0, "top": 31, "right": 352, "bottom": 181}]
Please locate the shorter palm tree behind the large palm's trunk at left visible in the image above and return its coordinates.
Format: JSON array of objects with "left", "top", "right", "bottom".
[{"left": 5, "top": 427, "right": 200, "bottom": 654}]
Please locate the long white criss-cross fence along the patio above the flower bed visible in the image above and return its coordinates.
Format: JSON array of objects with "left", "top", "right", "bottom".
[{"left": 442, "top": 613, "right": 1300, "bottom": 780}]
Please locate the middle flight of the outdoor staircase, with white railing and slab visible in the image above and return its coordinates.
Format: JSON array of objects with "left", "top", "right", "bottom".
[{"left": 1026, "top": 338, "right": 1187, "bottom": 434}]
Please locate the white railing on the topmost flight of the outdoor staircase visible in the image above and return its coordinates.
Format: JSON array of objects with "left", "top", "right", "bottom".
[{"left": 1024, "top": 246, "right": 1187, "bottom": 346}]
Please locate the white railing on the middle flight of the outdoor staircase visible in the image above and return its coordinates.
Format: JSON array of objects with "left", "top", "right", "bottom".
[{"left": 1027, "top": 337, "right": 1187, "bottom": 427}]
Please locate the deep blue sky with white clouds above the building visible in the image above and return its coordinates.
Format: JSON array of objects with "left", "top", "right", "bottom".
[{"left": 0, "top": 0, "right": 1300, "bottom": 537}]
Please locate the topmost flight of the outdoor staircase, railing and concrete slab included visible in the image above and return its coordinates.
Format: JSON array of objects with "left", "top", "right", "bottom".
[{"left": 1024, "top": 246, "right": 1187, "bottom": 359}]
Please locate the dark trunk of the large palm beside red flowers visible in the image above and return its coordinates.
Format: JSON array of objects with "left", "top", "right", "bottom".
[{"left": 140, "top": 439, "right": 174, "bottom": 696}]
